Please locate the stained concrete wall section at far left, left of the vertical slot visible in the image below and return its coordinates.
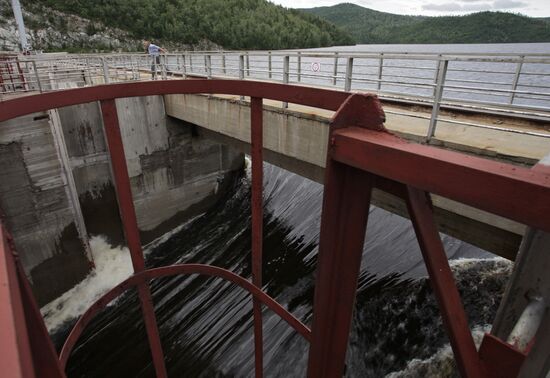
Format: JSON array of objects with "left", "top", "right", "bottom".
[{"left": 0, "top": 113, "right": 89, "bottom": 303}]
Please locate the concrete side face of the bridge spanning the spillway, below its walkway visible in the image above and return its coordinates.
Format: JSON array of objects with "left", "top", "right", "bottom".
[{"left": 165, "top": 95, "right": 525, "bottom": 260}]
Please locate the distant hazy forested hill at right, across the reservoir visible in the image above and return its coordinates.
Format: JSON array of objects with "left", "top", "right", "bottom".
[{"left": 301, "top": 3, "right": 550, "bottom": 43}]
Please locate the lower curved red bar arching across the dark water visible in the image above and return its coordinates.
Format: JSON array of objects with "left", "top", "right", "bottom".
[{"left": 59, "top": 264, "right": 311, "bottom": 366}]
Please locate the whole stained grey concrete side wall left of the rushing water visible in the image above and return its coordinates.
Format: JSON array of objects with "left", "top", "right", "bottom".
[{"left": 0, "top": 96, "right": 244, "bottom": 305}]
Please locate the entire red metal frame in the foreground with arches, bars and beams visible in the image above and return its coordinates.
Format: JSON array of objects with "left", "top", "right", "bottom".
[{"left": 0, "top": 80, "right": 550, "bottom": 377}]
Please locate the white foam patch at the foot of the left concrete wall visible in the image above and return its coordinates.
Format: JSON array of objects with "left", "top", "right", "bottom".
[{"left": 40, "top": 236, "right": 133, "bottom": 333}]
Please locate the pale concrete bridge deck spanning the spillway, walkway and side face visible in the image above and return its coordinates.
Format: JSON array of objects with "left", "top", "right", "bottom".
[{"left": 165, "top": 89, "right": 550, "bottom": 259}]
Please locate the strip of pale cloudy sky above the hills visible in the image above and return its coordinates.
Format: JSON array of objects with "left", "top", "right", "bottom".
[{"left": 269, "top": 0, "right": 550, "bottom": 17}]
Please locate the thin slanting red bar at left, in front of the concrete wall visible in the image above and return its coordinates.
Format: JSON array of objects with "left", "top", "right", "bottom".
[{"left": 101, "top": 100, "right": 167, "bottom": 377}]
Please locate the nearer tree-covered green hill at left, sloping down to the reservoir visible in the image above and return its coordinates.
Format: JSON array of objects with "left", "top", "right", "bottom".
[{"left": 21, "top": 0, "right": 353, "bottom": 49}]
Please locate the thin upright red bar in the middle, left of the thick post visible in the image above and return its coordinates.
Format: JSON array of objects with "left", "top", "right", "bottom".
[{"left": 250, "top": 97, "right": 264, "bottom": 378}]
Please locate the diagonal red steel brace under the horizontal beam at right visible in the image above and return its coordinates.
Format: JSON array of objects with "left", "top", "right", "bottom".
[{"left": 407, "top": 186, "right": 483, "bottom": 377}]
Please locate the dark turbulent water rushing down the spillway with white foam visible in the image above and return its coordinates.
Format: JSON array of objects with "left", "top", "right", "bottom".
[{"left": 43, "top": 160, "right": 510, "bottom": 377}]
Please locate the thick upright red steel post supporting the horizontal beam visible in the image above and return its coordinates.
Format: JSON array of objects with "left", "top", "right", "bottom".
[{"left": 308, "top": 159, "right": 374, "bottom": 378}]
